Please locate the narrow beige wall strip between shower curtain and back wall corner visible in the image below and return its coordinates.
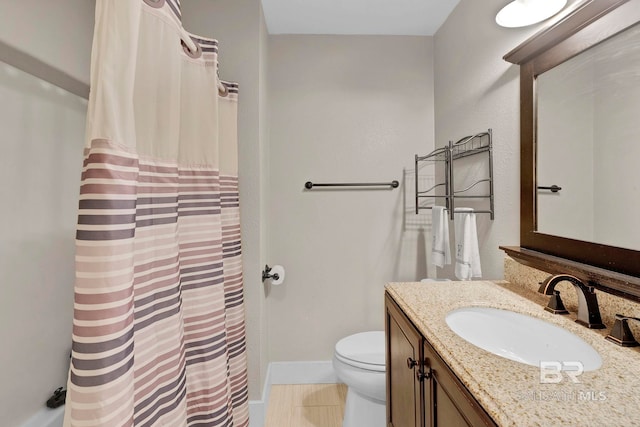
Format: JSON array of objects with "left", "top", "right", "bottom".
[{"left": 182, "top": 0, "right": 267, "bottom": 400}]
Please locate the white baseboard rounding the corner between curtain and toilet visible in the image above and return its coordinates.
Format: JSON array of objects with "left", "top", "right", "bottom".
[{"left": 249, "top": 361, "right": 339, "bottom": 427}]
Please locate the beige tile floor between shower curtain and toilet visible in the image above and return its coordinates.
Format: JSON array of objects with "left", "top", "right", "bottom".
[{"left": 265, "top": 384, "right": 347, "bottom": 427}]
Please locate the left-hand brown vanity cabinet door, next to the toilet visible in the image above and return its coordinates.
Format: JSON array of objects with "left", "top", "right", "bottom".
[{"left": 385, "top": 296, "right": 422, "bottom": 427}]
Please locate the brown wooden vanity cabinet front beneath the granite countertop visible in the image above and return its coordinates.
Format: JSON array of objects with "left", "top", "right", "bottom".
[{"left": 385, "top": 294, "right": 496, "bottom": 427}]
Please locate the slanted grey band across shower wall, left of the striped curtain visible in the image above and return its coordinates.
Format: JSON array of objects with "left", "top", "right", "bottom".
[{"left": 0, "top": 41, "right": 89, "bottom": 99}]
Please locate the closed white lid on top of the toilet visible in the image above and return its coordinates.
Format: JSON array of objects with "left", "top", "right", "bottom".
[{"left": 336, "top": 331, "right": 385, "bottom": 369}]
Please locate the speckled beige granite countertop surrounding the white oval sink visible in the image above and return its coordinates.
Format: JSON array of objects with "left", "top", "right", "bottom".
[{"left": 386, "top": 281, "right": 640, "bottom": 427}]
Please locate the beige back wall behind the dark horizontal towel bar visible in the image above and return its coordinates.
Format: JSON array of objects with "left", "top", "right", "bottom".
[{"left": 267, "top": 36, "right": 433, "bottom": 361}]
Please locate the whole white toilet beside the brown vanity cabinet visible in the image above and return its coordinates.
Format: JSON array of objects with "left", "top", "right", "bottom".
[{"left": 333, "top": 331, "right": 387, "bottom": 427}]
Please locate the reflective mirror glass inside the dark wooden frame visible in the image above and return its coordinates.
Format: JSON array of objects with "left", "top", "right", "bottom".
[{"left": 535, "top": 25, "right": 640, "bottom": 250}]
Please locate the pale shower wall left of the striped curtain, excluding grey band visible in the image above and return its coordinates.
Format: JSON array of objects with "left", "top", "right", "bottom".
[{"left": 0, "top": 0, "right": 94, "bottom": 426}]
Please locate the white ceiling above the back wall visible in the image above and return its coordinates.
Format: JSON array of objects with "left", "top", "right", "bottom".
[{"left": 262, "top": 0, "right": 459, "bottom": 36}]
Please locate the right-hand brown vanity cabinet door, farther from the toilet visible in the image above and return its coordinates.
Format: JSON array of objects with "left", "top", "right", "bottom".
[{"left": 423, "top": 340, "right": 495, "bottom": 427}]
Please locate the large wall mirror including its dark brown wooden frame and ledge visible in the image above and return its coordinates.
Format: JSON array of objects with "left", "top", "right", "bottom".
[{"left": 503, "top": 0, "right": 640, "bottom": 300}]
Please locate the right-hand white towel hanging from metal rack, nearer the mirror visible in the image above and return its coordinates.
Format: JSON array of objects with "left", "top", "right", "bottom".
[{"left": 453, "top": 208, "right": 482, "bottom": 280}]
